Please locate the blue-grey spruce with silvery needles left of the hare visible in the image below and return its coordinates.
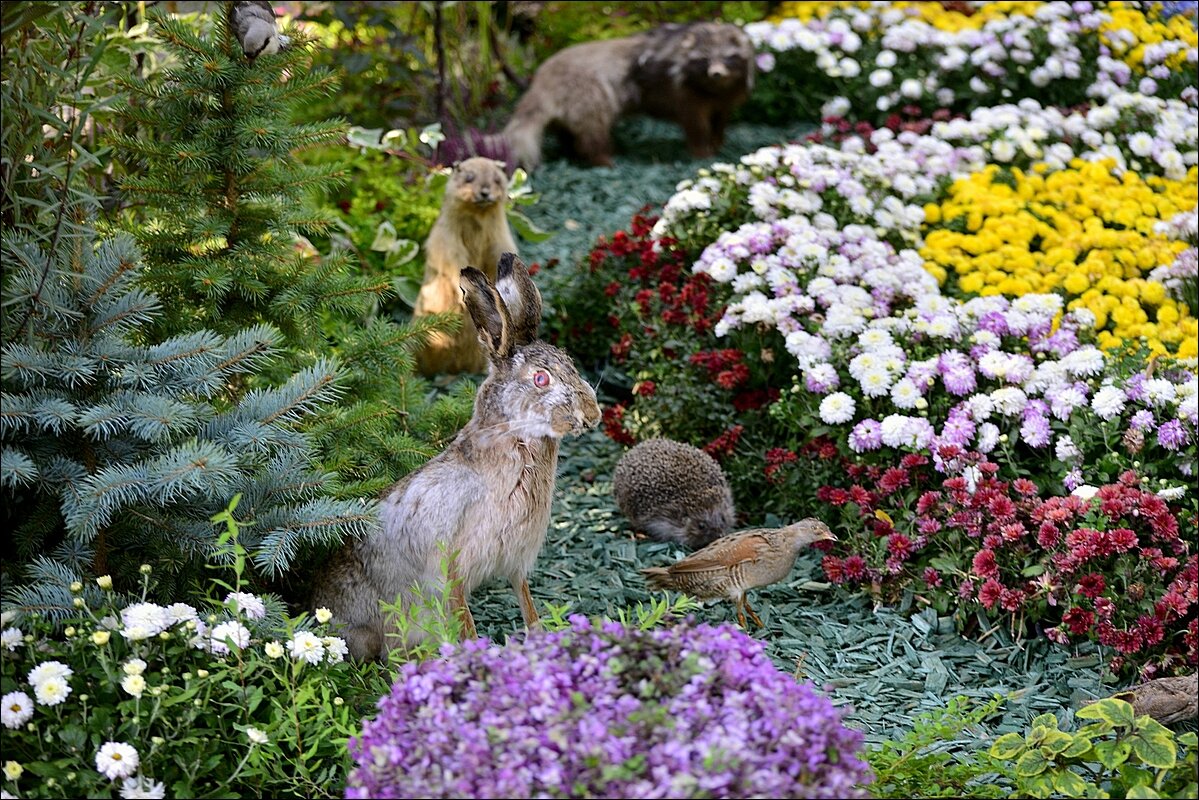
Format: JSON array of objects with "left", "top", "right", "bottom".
[{"left": 0, "top": 227, "right": 375, "bottom": 610}]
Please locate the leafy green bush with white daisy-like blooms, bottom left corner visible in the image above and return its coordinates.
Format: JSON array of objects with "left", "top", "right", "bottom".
[{"left": 0, "top": 506, "right": 386, "bottom": 798}]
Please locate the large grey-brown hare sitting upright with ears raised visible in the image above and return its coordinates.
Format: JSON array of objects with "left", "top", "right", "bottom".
[{"left": 313, "top": 253, "right": 600, "bottom": 660}]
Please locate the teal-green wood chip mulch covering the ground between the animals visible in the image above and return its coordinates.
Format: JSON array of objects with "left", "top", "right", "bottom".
[{"left": 462, "top": 120, "right": 1113, "bottom": 744}]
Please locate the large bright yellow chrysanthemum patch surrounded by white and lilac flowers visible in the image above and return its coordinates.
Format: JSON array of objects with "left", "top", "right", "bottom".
[{"left": 920, "top": 158, "right": 1199, "bottom": 357}]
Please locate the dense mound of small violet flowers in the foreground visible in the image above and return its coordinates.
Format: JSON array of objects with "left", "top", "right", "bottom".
[{"left": 347, "top": 615, "right": 872, "bottom": 798}]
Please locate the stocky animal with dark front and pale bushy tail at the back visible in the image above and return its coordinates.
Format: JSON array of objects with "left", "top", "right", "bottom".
[{"left": 504, "top": 23, "right": 754, "bottom": 169}]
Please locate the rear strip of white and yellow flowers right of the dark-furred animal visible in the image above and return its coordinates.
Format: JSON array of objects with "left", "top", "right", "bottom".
[{"left": 746, "top": 2, "right": 1199, "bottom": 122}]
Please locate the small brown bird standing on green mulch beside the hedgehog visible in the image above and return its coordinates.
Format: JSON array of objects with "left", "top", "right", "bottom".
[{"left": 640, "top": 517, "right": 837, "bottom": 627}]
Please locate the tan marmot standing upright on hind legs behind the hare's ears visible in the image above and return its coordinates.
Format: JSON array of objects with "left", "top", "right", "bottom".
[{"left": 412, "top": 157, "right": 517, "bottom": 375}]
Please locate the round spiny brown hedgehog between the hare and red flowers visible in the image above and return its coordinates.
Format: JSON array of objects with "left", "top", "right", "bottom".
[{"left": 611, "top": 439, "right": 735, "bottom": 548}]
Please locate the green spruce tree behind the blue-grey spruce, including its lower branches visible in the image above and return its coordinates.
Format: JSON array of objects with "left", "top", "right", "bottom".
[{"left": 107, "top": 4, "right": 471, "bottom": 498}]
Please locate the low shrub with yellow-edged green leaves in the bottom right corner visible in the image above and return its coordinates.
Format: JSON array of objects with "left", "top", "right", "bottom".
[{"left": 990, "top": 697, "right": 1199, "bottom": 798}]
